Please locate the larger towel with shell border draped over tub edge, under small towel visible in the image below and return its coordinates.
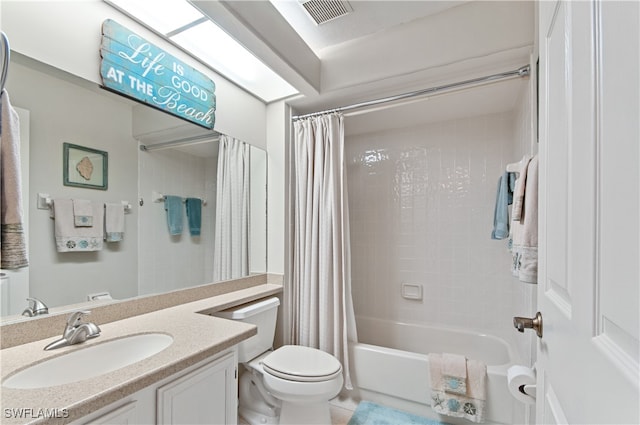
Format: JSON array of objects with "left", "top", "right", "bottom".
[{"left": 429, "top": 353, "right": 487, "bottom": 422}]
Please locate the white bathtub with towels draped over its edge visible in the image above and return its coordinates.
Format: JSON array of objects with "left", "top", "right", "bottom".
[{"left": 350, "top": 317, "right": 525, "bottom": 424}]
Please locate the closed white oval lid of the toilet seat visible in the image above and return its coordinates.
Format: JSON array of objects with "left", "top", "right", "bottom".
[{"left": 262, "top": 345, "right": 342, "bottom": 382}]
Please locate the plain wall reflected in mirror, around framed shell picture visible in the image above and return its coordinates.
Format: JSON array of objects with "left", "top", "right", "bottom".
[{"left": 6, "top": 61, "right": 138, "bottom": 306}]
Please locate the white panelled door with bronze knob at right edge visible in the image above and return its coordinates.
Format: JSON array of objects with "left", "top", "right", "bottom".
[{"left": 536, "top": 1, "right": 640, "bottom": 424}]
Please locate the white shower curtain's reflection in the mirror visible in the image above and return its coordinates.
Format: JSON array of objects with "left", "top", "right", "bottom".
[{"left": 213, "top": 135, "right": 249, "bottom": 282}]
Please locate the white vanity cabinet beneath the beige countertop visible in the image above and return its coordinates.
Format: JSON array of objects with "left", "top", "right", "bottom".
[{"left": 76, "top": 349, "right": 238, "bottom": 425}]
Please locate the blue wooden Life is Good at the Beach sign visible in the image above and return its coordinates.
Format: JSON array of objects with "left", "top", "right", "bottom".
[{"left": 100, "top": 19, "right": 216, "bottom": 129}]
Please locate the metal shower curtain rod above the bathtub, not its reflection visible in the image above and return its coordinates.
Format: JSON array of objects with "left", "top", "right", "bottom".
[{"left": 292, "top": 65, "right": 530, "bottom": 121}]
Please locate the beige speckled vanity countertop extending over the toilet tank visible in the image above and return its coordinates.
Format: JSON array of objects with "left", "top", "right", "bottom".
[{"left": 0, "top": 284, "right": 282, "bottom": 424}]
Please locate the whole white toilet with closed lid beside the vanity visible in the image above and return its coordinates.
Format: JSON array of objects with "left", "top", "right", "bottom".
[{"left": 213, "top": 297, "right": 343, "bottom": 425}]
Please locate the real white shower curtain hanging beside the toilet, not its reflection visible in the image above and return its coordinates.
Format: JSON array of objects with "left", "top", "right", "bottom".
[{"left": 285, "top": 114, "right": 356, "bottom": 389}]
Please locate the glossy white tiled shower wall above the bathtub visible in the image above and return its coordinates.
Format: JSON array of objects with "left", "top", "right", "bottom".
[{"left": 345, "top": 113, "right": 522, "bottom": 336}]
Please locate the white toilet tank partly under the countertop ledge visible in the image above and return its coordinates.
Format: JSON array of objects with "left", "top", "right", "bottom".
[{"left": 212, "top": 297, "right": 280, "bottom": 363}]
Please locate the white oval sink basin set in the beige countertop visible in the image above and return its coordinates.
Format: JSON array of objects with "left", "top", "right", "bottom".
[{"left": 2, "top": 333, "right": 173, "bottom": 389}]
